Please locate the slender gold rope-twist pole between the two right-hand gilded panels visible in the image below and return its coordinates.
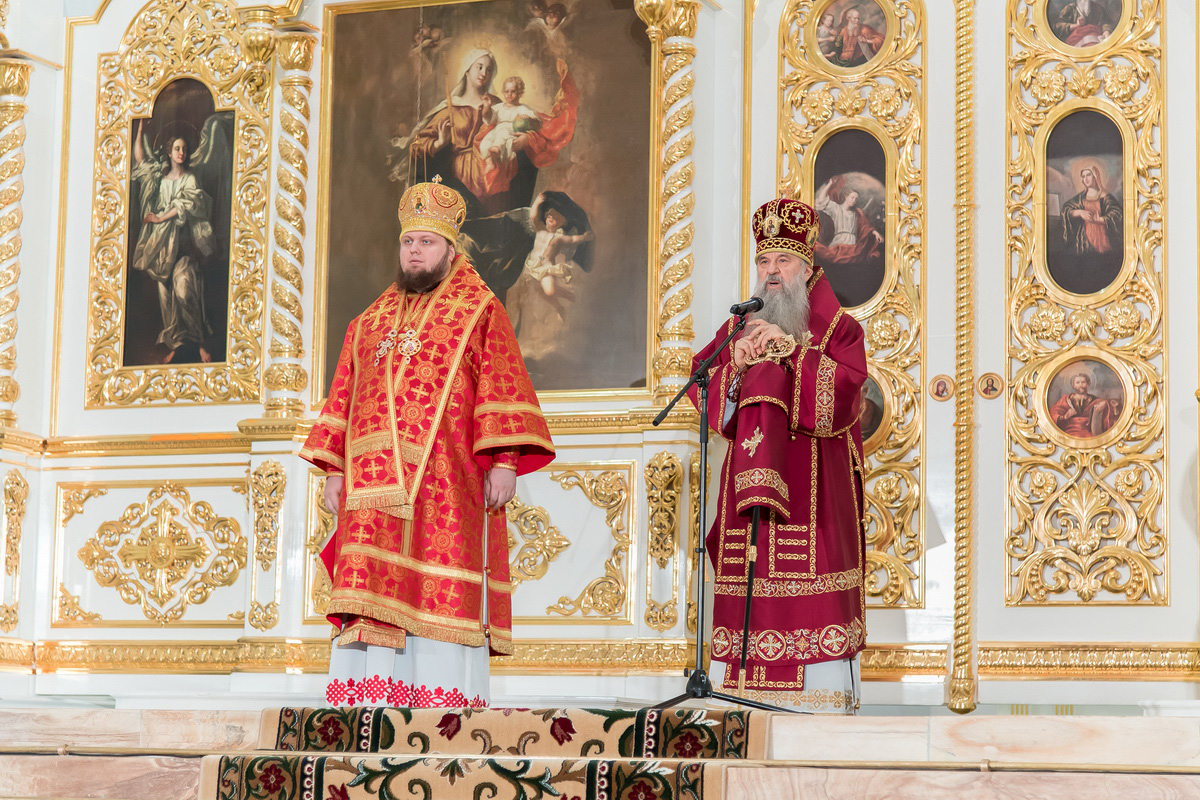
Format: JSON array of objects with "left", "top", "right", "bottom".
[{"left": 947, "top": 0, "right": 977, "bottom": 714}]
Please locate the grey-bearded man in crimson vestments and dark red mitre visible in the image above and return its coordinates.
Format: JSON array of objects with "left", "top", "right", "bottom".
[{"left": 692, "top": 199, "right": 866, "bottom": 714}]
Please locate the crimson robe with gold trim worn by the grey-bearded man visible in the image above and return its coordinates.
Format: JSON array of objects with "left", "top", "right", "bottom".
[{"left": 692, "top": 271, "right": 866, "bottom": 692}]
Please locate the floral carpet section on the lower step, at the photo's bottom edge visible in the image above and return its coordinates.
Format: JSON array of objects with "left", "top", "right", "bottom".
[{"left": 199, "top": 753, "right": 725, "bottom": 800}]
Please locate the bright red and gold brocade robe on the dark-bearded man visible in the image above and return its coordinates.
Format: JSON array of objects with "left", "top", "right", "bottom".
[{"left": 300, "top": 255, "right": 554, "bottom": 654}]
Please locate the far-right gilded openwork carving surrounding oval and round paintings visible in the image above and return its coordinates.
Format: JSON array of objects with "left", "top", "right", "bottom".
[{"left": 1008, "top": 0, "right": 1169, "bottom": 606}]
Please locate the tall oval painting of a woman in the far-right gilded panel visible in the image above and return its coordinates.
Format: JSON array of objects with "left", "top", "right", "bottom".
[{"left": 1045, "top": 109, "right": 1124, "bottom": 295}]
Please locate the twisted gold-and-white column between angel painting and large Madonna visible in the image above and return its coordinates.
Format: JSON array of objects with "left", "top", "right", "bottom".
[{"left": 263, "top": 31, "right": 317, "bottom": 419}]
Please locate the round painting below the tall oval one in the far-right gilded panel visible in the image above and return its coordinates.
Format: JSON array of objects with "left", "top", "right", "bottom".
[{"left": 1045, "top": 357, "right": 1126, "bottom": 443}]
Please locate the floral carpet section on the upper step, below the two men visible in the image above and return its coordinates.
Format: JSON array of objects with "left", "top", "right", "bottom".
[{"left": 258, "top": 706, "right": 772, "bottom": 759}]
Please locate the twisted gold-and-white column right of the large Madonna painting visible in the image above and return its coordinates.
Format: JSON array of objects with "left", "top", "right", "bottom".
[{"left": 637, "top": 0, "right": 700, "bottom": 399}]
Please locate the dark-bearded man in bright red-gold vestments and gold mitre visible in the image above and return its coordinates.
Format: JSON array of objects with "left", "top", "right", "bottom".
[{"left": 300, "top": 182, "right": 554, "bottom": 708}]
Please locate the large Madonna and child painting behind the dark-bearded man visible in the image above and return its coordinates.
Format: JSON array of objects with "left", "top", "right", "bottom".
[{"left": 322, "top": 0, "right": 650, "bottom": 391}]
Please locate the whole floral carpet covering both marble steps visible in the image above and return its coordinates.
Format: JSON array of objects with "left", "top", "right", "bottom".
[{"left": 199, "top": 708, "right": 773, "bottom": 800}]
